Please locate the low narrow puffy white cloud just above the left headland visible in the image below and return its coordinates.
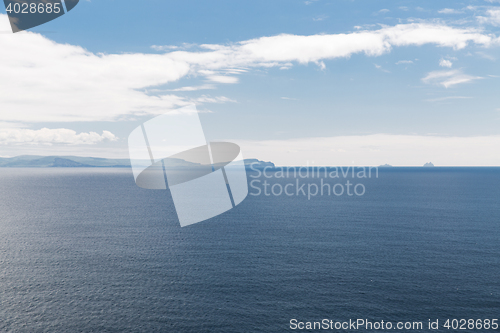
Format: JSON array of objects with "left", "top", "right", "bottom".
[{"left": 0, "top": 128, "right": 118, "bottom": 145}]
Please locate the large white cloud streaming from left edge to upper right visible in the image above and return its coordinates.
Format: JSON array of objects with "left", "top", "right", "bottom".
[{"left": 0, "top": 14, "right": 494, "bottom": 123}]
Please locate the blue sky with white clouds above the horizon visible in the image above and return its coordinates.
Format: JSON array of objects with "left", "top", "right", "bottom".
[{"left": 0, "top": 0, "right": 500, "bottom": 166}]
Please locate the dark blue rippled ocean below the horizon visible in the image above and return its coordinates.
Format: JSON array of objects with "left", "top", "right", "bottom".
[{"left": 0, "top": 168, "right": 500, "bottom": 332}]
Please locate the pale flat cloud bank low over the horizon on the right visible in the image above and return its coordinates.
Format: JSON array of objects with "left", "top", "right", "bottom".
[{"left": 235, "top": 134, "right": 500, "bottom": 166}]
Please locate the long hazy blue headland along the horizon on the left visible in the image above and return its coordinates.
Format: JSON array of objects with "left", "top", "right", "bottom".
[{"left": 0, "top": 155, "right": 275, "bottom": 169}]
